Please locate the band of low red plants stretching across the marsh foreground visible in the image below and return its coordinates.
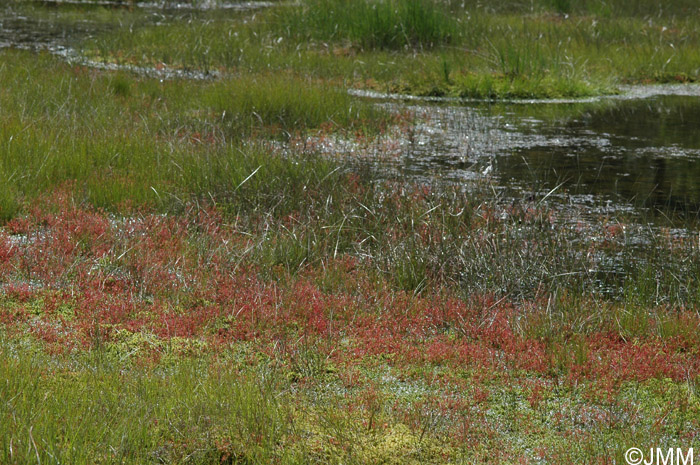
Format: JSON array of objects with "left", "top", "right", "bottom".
[{"left": 0, "top": 191, "right": 700, "bottom": 394}]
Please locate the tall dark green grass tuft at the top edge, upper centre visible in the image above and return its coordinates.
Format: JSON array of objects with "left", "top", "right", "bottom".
[{"left": 278, "top": 0, "right": 458, "bottom": 49}]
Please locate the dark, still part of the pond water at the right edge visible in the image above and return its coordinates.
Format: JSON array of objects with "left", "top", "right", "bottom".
[{"left": 497, "top": 96, "right": 700, "bottom": 216}]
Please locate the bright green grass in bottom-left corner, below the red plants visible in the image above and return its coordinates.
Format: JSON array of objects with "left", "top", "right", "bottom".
[{"left": 0, "top": 342, "right": 290, "bottom": 464}]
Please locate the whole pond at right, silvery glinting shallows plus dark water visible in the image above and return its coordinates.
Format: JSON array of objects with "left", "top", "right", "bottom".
[{"left": 378, "top": 93, "right": 700, "bottom": 224}]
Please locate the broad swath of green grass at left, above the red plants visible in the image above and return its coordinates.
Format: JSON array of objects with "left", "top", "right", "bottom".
[{"left": 0, "top": 51, "right": 388, "bottom": 212}]
